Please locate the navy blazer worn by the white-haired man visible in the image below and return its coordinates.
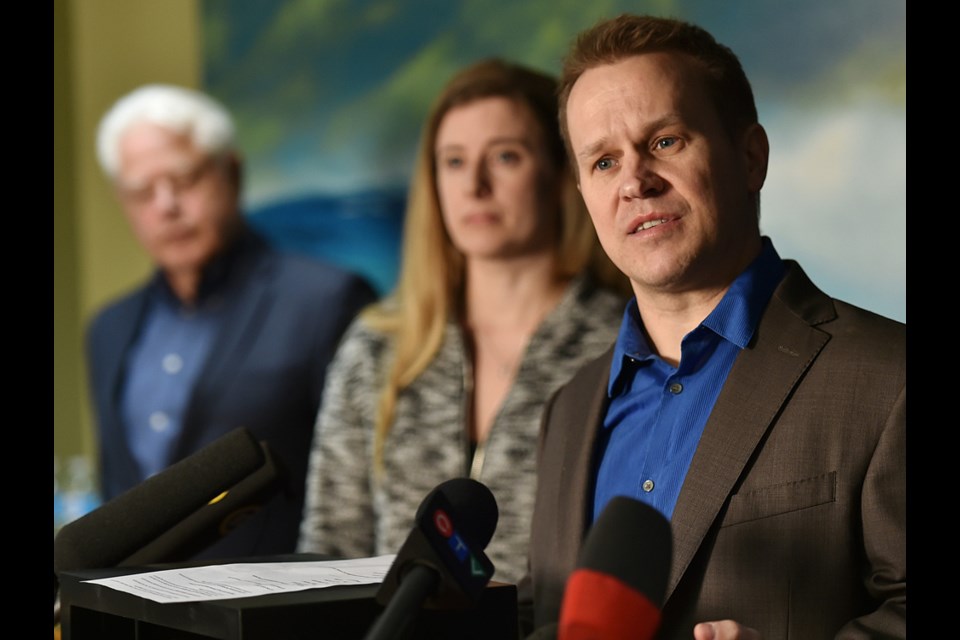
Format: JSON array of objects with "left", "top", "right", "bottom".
[{"left": 87, "top": 230, "right": 376, "bottom": 558}]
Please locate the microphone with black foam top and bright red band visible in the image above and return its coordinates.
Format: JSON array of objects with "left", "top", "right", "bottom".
[{"left": 557, "top": 496, "right": 673, "bottom": 640}]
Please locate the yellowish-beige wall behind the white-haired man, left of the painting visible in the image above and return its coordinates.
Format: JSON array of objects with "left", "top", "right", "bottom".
[{"left": 53, "top": 0, "right": 200, "bottom": 456}]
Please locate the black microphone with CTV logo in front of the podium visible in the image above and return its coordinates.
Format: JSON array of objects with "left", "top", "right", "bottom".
[{"left": 366, "top": 478, "right": 499, "bottom": 640}]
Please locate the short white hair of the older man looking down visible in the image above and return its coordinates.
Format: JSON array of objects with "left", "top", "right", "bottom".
[{"left": 97, "top": 84, "right": 234, "bottom": 178}]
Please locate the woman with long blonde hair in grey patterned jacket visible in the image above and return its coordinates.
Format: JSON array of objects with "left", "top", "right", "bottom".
[{"left": 298, "top": 60, "right": 627, "bottom": 582}]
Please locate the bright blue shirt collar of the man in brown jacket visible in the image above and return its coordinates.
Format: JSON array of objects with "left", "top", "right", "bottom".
[{"left": 607, "top": 236, "right": 786, "bottom": 397}]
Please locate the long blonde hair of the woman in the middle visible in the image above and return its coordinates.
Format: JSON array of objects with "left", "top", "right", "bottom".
[{"left": 363, "top": 58, "right": 629, "bottom": 470}]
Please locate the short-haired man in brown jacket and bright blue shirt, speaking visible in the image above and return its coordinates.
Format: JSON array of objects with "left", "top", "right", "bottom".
[{"left": 520, "top": 15, "right": 907, "bottom": 640}]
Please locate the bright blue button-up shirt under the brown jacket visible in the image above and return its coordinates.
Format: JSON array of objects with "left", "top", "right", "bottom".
[{"left": 593, "top": 237, "right": 785, "bottom": 519}]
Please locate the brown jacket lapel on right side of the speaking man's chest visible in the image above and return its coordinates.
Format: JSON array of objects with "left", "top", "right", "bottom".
[{"left": 667, "top": 267, "right": 833, "bottom": 598}]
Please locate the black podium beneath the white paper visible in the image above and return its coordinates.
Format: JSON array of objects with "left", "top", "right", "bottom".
[{"left": 60, "top": 557, "right": 519, "bottom": 640}]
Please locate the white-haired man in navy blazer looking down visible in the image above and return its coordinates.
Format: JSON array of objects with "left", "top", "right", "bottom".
[{"left": 87, "top": 85, "right": 375, "bottom": 558}]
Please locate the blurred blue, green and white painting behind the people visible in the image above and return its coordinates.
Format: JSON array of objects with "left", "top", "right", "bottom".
[{"left": 202, "top": 0, "right": 906, "bottom": 321}]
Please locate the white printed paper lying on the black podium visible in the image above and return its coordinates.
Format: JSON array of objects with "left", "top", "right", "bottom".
[{"left": 85, "top": 554, "right": 396, "bottom": 602}]
